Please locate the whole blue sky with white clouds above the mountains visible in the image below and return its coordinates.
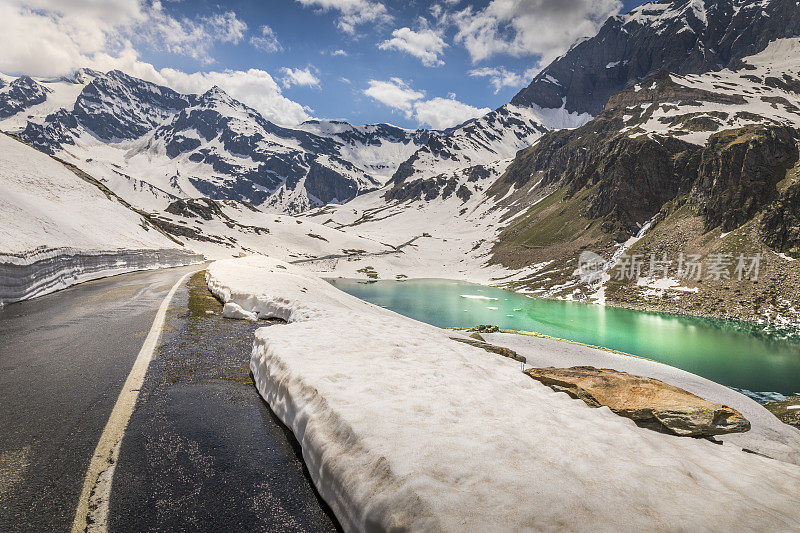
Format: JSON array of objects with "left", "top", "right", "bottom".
[{"left": 0, "top": 0, "right": 642, "bottom": 127}]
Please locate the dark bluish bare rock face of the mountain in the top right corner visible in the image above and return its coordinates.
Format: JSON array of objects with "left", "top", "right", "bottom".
[{"left": 511, "top": 0, "right": 800, "bottom": 115}]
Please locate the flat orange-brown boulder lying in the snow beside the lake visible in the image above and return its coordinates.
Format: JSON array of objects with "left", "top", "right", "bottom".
[{"left": 525, "top": 366, "right": 750, "bottom": 437}]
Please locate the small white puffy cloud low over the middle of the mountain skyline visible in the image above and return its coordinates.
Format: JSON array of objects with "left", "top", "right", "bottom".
[{"left": 363, "top": 78, "right": 490, "bottom": 129}]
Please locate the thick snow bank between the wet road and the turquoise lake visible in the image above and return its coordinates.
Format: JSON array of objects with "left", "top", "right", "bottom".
[{"left": 207, "top": 257, "right": 800, "bottom": 531}]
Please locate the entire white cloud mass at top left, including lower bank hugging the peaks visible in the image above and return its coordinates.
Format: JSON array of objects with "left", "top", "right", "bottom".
[{"left": 0, "top": 0, "right": 310, "bottom": 125}]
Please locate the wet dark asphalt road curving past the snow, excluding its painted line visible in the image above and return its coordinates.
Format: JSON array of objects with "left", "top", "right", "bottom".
[{"left": 0, "top": 266, "right": 336, "bottom": 532}]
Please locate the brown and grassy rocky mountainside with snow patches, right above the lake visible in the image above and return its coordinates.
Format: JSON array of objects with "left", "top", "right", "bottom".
[{"left": 487, "top": 37, "right": 800, "bottom": 324}]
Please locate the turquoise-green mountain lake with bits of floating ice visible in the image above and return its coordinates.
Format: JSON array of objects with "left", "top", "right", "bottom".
[{"left": 329, "top": 279, "right": 800, "bottom": 394}]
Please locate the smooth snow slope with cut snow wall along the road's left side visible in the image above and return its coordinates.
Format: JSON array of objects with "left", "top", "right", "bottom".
[{"left": 0, "top": 135, "right": 198, "bottom": 304}]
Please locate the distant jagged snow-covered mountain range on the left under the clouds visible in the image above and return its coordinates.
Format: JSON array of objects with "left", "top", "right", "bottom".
[{"left": 0, "top": 70, "right": 437, "bottom": 213}]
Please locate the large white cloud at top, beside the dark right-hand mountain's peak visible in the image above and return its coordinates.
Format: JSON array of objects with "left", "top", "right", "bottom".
[{"left": 449, "top": 0, "right": 622, "bottom": 64}]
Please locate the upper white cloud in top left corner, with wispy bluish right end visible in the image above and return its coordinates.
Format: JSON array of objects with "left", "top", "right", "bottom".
[{"left": 0, "top": 0, "right": 247, "bottom": 75}]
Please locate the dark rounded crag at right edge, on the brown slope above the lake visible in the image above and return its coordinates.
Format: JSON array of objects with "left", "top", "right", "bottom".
[{"left": 692, "top": 127, "right": 798, "bottom": 231}]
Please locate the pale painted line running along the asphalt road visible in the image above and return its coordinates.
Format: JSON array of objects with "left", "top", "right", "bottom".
[{"left": 72, "top": 272, "right": 194, "bottom": 533}]
